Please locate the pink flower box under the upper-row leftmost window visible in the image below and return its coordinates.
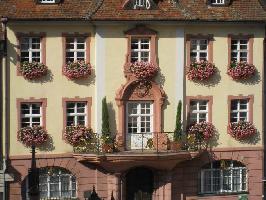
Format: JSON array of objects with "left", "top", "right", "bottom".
[{"left": 19, "top": 61, "right": 48, "bottom": 80}]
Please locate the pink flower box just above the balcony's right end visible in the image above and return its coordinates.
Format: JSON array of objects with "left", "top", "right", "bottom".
[{"left": 188, "top": 121, "right": 215, "bottom": 141}]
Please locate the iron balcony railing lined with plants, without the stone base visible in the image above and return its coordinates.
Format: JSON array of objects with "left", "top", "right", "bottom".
[{"left": 71, "top": 132, "right": 208, "bottom": 154}]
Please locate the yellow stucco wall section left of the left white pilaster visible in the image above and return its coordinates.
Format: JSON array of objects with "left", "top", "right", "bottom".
[{"left": 8, "top": 23, "right": 95, "bottom": 155}]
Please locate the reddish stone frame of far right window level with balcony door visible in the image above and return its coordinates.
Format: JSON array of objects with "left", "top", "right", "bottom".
[{"left": 228, "top": 95, "right": 254, "bottom": 124}]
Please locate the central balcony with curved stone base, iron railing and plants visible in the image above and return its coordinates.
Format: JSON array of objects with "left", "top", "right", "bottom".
[{"left": 73, "top": 132, "right": 206, "bottom": 172}]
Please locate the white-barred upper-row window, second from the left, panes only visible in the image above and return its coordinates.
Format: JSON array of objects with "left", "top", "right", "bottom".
[{"left": 66, "top": 37, "right": 87, "bottom": 62}]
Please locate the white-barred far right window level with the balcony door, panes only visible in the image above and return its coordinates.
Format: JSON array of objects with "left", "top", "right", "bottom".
[{"left": 230, "top": 99, "right": 249, "bottom": 122}]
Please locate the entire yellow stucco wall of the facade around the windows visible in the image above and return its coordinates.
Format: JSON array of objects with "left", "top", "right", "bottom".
[{"left": 8, "top": 23, "right": 264, "bottom": 155}]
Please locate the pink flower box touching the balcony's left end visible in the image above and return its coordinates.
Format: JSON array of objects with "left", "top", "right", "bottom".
[{"left": 64, "top": 125, "right": 98, "bottom": 152}]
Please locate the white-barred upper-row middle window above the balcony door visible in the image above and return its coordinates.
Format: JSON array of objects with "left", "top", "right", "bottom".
[{"left": 131, "top": 38, "right": 150, "bottom": 62}]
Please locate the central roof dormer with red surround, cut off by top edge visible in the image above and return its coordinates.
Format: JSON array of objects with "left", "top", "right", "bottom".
[{"left": 122, "top": 0, "right": 158, "bottom": 10}]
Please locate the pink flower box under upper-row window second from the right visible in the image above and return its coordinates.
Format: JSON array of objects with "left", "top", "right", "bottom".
[{"left": 187, "top": 60, "right": 216, "bottom": 81}]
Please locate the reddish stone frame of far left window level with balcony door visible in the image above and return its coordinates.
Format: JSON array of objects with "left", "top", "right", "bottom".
[{"left": 17, "top": 98, "right": 47, "bottom": 130}]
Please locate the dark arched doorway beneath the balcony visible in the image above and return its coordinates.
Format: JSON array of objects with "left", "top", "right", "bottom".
[{"left": 126, "top": 167, "right": 154, "bottom": 200}]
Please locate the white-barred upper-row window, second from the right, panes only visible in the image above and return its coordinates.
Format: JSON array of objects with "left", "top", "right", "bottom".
[{"left": 190, "top": 39, "right": 208, "bottom": 62}]
